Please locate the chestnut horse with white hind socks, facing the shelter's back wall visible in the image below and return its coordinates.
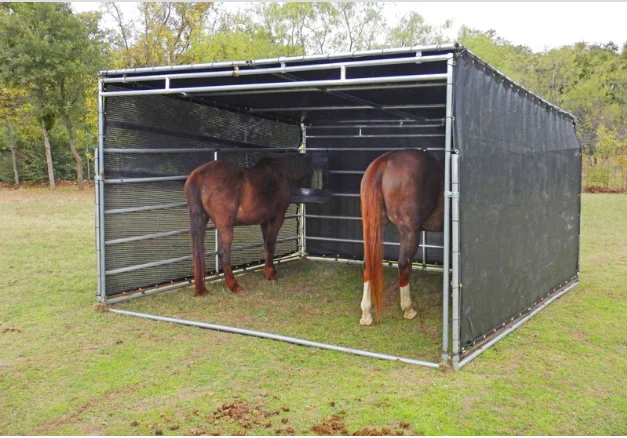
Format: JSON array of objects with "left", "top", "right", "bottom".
[{"left": 360, "top": 150, "right": 444, "bottom": 325}]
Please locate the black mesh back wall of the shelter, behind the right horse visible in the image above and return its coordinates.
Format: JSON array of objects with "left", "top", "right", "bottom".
[{"left": 306, "top": 130, "right": 444, "bottom": 264}]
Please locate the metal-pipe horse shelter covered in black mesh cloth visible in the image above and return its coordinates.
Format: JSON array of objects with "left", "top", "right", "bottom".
[{"left": 95, "top": 44, "right": 581, "bottom": 369}]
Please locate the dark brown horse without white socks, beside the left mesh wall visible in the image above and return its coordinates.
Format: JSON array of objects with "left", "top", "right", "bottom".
[{"left": 185, "top": 152, "right": 311, "bottom": 295}]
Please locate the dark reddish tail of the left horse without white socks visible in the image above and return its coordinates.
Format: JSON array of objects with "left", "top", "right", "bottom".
[{"left": 185, "top": 175, "right": 209, "bottom": 295}]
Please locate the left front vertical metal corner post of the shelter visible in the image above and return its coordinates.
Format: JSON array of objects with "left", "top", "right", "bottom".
[{"left": 94, "top": 78, "right": 107, "bottom": 304}]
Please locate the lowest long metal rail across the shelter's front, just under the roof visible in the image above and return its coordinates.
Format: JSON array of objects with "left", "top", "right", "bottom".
[{"left": 100, "top": 73, "right": 447, "bottom": 96}]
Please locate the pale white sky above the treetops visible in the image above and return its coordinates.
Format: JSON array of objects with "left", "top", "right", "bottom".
[{"left": 72, "top": 2, "right": 627, "bottom": 52}]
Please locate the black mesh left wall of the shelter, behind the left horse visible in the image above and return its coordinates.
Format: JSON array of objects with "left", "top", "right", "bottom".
[{"left": 104, "top": 96, "right": 301, "bottom": 296}]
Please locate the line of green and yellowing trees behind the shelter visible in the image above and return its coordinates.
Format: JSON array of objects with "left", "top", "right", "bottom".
[{"left": 0, "top": 2, "right": 627, "bottom": 188}]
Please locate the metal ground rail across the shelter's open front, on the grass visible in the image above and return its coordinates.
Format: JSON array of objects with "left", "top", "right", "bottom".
[{"left": 109, "top": 309, "right": 440, "bottom": 368}]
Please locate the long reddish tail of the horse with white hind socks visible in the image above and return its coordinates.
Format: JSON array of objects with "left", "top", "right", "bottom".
[{"left": 360, "top": 159, "right": 386, "bottom": 321}]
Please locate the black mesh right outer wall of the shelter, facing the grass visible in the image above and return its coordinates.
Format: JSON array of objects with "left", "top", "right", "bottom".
[{"left": 454, "top": 56, "right": 581, "bottom": 346}]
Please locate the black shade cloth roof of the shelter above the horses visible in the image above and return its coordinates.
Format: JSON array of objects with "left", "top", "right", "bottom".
[{"left": 100, "top": 43, "right": 574, "bottom": 124}]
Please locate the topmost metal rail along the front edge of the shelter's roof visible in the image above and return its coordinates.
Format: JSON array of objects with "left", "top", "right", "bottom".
[{"left": 100, "top": 43, "right": 460, "bottom": 76}]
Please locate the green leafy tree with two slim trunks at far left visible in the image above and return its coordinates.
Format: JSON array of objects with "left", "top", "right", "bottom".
[{"left": 0, "top": 3, "right": 104, "bottom": 190}]
